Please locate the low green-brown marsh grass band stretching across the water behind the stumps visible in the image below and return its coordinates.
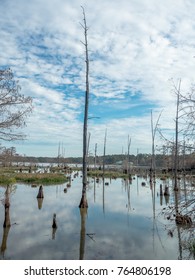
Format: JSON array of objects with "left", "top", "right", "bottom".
[{"left": 0, "top": 166, "right": 195, "bottom": 185}]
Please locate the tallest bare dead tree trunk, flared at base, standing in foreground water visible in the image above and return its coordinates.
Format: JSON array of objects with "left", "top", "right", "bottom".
[{"left": 79, "top": 6, "right": 89, "bottom": 208}]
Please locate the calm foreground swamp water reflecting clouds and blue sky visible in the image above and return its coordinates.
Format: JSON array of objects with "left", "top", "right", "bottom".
[{"left": 0, "top": 172, "right": 193, "bottom": 260}]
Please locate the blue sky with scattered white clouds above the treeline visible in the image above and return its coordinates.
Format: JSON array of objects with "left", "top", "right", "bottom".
[{"left": 0, "top": 0, "right": 195, "bottom": 157}]
